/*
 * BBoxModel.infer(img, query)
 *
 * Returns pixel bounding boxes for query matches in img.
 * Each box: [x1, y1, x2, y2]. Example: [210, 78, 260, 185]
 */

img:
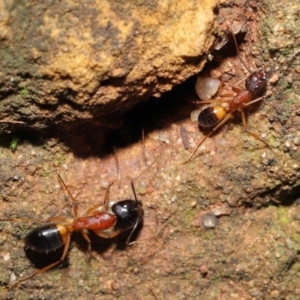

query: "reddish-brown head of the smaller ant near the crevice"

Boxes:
[245, 70, 268, 97]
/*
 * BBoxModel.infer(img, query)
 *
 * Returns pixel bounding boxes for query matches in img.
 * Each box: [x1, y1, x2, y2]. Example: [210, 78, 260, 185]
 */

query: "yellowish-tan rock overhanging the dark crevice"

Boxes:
[0, 0, 218, 128]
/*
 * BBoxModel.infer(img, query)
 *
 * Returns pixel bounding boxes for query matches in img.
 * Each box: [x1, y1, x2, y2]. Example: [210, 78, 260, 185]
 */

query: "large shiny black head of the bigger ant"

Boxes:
[111, 182, 144, 244]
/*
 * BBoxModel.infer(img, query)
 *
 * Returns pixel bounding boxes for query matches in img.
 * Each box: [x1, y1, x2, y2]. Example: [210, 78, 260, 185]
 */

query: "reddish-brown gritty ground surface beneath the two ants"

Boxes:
[0, 0, 300, 300]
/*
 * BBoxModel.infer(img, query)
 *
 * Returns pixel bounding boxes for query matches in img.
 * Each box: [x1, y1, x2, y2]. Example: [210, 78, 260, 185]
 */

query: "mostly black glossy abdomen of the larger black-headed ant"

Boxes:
[25, 224, 65, 253]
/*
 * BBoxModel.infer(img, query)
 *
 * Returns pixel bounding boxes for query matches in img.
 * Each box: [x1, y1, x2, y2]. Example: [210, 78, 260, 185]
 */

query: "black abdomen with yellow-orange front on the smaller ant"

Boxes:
[198, 105, 227, 128]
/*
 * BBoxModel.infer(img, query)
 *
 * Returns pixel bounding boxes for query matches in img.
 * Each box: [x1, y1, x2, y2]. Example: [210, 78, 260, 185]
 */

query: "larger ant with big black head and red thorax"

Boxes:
[0, 174, 144, 289]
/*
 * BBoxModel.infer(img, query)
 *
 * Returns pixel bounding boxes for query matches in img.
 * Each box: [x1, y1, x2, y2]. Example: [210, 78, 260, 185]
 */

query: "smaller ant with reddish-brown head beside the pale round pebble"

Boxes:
[185, 33, 271, 163]
